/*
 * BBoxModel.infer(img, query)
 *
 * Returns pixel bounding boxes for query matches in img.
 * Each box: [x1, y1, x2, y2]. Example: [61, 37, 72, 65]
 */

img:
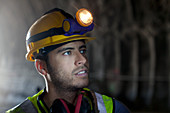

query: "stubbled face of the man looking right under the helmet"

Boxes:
[47, 41, 89, 90]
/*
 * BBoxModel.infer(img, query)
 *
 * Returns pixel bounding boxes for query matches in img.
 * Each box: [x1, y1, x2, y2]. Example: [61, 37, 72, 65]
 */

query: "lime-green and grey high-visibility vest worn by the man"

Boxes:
[6, 90, 114, 113]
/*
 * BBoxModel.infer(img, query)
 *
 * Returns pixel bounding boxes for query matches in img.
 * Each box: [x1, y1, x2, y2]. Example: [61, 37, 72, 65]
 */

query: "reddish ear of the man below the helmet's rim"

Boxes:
[35, 59, 47, 75]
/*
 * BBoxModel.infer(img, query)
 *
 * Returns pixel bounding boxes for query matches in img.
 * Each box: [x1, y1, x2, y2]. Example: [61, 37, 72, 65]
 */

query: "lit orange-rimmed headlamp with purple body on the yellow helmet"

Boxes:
[63, 8, 94, 35]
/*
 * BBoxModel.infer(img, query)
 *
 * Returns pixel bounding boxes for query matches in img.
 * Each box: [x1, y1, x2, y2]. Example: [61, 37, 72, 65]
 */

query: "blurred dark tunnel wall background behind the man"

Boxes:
[0, 0, 170, 113]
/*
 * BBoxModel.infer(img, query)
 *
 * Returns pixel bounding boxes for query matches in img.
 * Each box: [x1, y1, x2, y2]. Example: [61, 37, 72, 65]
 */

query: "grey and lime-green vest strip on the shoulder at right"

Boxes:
[95, 92, 113, 113]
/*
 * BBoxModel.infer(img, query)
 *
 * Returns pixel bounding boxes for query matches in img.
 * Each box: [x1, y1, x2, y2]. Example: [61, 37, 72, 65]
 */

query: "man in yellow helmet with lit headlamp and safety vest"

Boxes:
[7, 8, 129, 113]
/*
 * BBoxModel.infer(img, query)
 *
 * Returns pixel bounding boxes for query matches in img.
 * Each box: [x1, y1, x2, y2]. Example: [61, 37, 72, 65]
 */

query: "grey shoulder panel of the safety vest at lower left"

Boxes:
[6, 99, 37, 113]
